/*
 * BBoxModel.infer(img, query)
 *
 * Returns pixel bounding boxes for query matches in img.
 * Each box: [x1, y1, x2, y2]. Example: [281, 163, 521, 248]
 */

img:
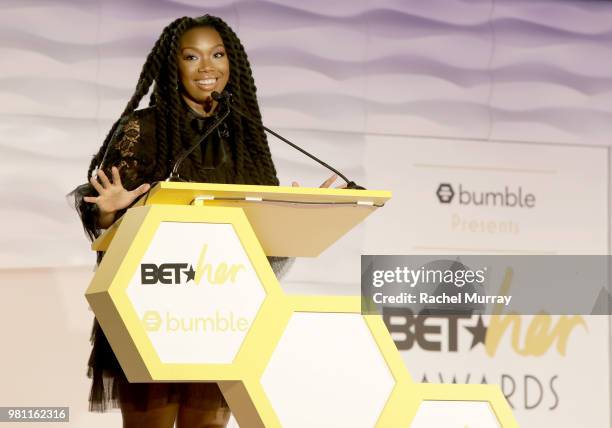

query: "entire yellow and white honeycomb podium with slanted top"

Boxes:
[86, 182, 516, 428]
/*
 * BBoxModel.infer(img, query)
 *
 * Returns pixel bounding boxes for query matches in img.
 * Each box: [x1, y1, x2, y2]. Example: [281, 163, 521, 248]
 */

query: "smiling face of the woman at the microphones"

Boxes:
[177, 27, 230, 116]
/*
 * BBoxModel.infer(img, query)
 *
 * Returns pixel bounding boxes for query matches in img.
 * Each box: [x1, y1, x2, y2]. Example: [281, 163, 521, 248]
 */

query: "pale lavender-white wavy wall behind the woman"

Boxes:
[0, 0, 612, 426]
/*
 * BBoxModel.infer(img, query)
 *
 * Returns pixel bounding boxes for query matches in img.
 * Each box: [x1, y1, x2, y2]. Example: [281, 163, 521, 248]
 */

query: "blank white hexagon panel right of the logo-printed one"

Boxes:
[261, 312, 395, 428]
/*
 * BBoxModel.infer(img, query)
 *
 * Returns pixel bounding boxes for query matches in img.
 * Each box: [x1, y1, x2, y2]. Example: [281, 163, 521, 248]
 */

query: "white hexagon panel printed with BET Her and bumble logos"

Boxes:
[126, 222, 265, 364]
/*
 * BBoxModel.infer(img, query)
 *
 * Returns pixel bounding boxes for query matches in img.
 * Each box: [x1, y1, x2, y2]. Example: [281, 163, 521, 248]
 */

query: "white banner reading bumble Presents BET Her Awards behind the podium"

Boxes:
[367, 137, 610, 427]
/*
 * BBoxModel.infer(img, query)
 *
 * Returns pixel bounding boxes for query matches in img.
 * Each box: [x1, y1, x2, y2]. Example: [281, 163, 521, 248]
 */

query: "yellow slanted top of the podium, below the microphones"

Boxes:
[92, 182, 391, 257]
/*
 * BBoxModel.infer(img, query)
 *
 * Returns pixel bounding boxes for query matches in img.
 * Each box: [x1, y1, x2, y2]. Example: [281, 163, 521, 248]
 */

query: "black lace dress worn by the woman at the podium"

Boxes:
[74, 105, 287, 411]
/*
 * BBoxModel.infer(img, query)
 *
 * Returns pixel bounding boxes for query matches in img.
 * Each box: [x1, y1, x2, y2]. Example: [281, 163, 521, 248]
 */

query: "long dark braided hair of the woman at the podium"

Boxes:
[75, 15, 279, 238]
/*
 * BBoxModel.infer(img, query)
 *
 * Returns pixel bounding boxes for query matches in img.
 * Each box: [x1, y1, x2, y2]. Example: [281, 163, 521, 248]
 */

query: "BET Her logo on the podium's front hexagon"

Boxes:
[140, 244, 246, 285]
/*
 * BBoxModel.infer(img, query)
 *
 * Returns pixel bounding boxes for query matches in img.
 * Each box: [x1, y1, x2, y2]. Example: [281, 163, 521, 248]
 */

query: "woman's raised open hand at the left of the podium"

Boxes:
[83, 167, 151, 217]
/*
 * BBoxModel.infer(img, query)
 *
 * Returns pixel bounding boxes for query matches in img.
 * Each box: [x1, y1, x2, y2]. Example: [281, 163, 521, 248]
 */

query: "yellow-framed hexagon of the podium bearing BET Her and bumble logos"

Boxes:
[86, 206, 280, 382]
